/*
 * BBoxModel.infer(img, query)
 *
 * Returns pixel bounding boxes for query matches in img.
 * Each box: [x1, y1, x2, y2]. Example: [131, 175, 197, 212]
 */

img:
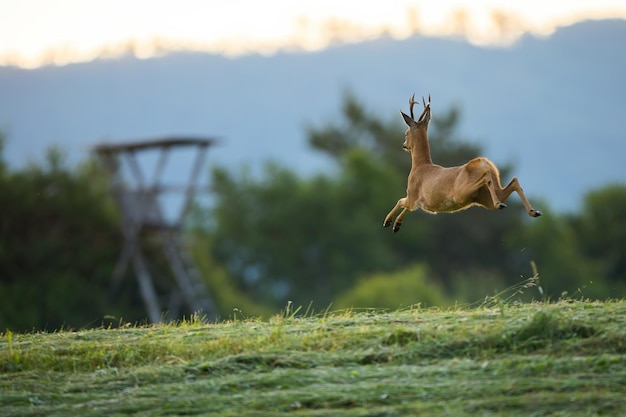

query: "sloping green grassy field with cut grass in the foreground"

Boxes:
[0, 301, 626, 417]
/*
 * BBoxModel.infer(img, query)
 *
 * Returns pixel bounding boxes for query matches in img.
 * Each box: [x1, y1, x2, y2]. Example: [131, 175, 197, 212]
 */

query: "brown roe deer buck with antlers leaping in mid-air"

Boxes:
[383, 94, 541, 233]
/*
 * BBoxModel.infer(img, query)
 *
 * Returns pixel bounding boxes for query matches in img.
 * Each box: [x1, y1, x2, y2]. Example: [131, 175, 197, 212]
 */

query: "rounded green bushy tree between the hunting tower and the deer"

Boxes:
[205, 151, 397, 305]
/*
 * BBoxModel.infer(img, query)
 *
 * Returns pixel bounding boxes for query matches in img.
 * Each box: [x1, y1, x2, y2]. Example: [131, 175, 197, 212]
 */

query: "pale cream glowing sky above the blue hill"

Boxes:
[0, 0, 626, 68]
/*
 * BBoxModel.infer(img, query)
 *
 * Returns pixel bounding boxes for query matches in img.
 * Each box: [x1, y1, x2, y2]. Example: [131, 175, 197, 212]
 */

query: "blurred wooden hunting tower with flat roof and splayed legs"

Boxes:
[94, 138, 217, 323]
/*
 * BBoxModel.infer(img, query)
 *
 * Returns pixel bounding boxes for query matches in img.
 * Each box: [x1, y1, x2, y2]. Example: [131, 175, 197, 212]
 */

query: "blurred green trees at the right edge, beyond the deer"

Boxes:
[512, 184, 626, 299]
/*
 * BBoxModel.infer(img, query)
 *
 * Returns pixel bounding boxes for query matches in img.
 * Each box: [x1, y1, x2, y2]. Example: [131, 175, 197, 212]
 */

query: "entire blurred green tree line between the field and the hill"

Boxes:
[0, 94, 626, 330]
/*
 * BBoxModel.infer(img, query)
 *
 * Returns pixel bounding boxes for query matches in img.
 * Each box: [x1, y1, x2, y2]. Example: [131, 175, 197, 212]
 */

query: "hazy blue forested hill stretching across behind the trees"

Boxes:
[0, 20, 626, 210]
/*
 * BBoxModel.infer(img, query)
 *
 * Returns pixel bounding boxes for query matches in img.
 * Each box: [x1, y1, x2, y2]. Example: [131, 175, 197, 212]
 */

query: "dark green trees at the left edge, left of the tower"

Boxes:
[0, 141, 143, 331]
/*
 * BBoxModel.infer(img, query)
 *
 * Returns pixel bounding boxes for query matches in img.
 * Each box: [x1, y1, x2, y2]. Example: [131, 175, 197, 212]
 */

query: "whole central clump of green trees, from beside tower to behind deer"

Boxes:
[210, 91, 526, 308]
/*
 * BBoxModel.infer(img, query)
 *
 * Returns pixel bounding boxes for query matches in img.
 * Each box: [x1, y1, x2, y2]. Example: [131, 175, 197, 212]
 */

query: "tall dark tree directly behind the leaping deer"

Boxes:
[307, 93, 525, 289]
